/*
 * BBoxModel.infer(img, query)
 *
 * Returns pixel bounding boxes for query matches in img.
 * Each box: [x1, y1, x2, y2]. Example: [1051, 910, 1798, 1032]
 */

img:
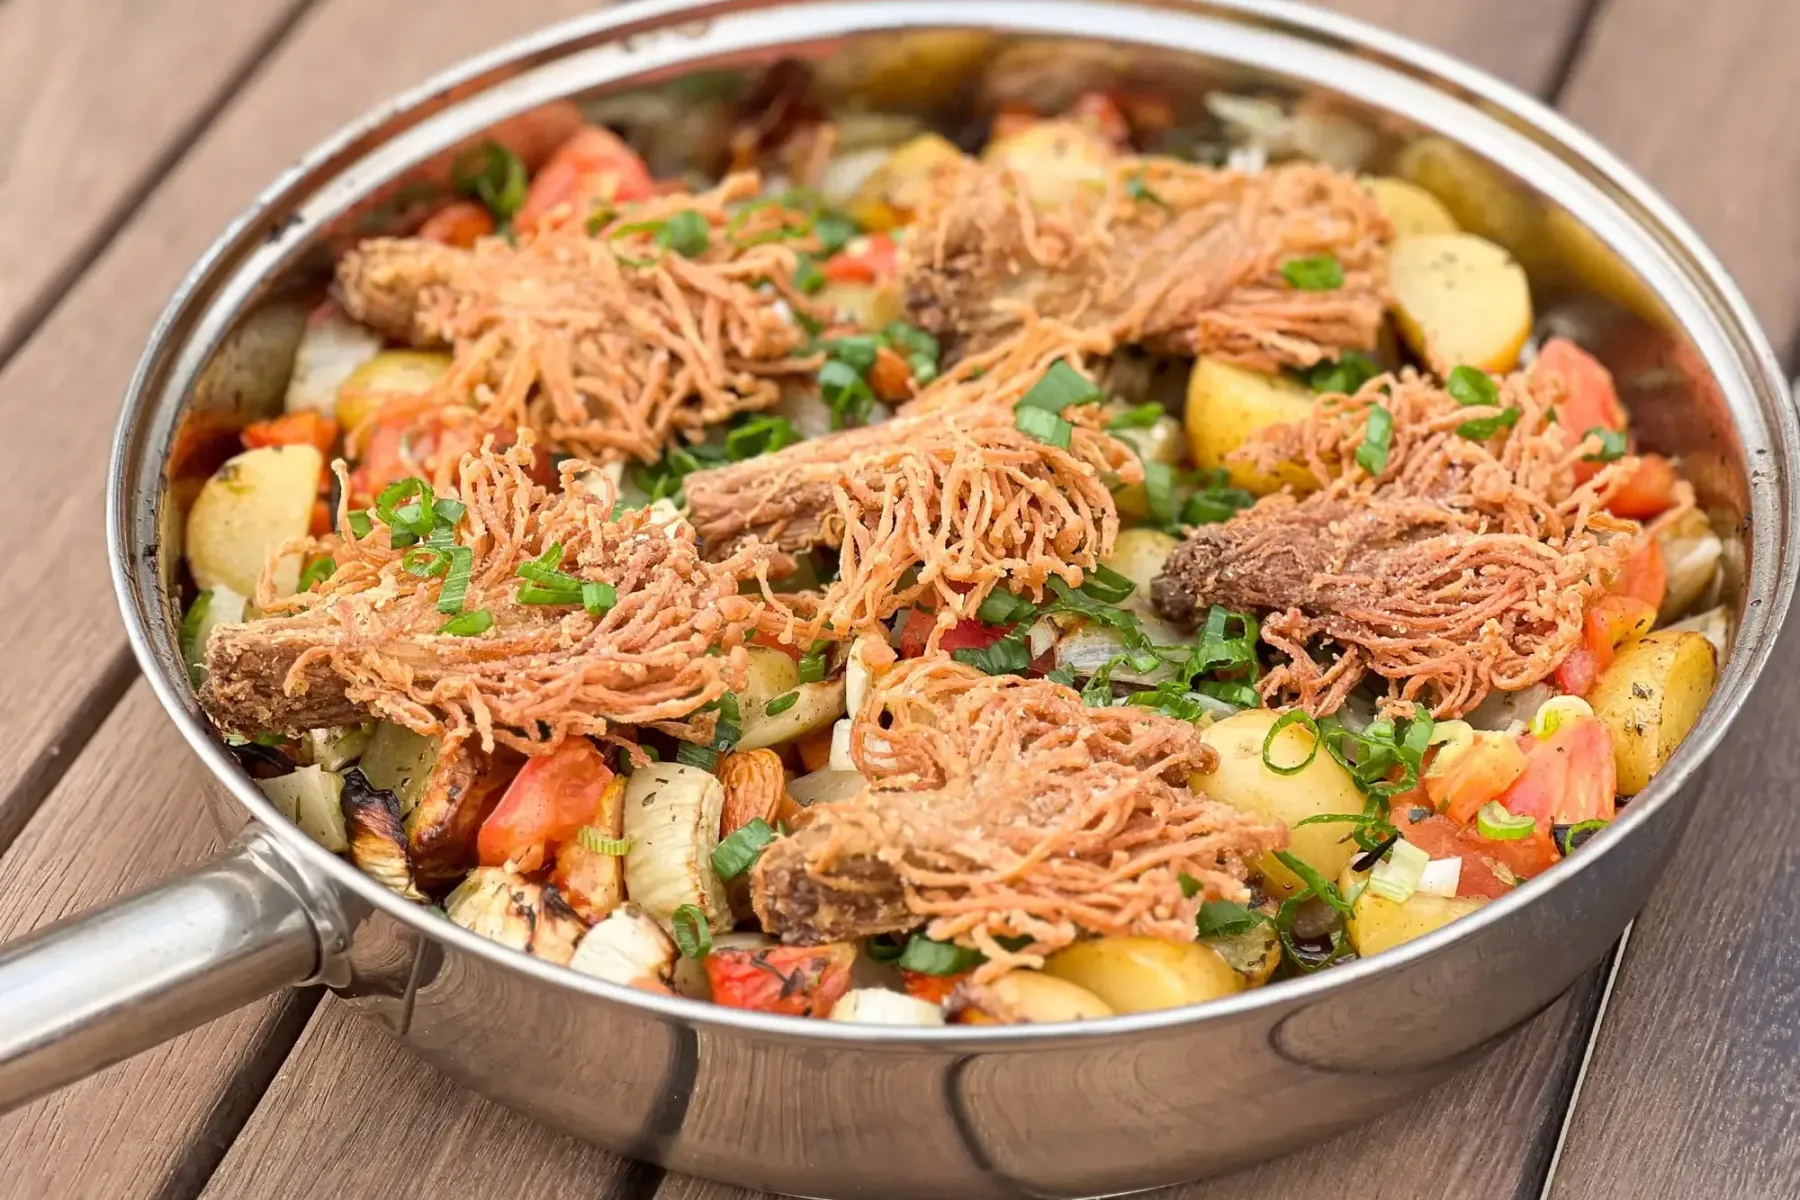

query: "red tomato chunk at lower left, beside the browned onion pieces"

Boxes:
[475, 738, 612, 871]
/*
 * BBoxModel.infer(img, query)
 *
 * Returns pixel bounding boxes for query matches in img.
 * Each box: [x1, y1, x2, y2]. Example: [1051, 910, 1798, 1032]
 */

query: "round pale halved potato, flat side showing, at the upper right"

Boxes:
[1388, 234, 1532, 374]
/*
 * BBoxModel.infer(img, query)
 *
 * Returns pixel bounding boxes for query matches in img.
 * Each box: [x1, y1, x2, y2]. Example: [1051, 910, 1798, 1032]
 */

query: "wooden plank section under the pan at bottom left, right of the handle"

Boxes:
[202, 999, 646, 1200]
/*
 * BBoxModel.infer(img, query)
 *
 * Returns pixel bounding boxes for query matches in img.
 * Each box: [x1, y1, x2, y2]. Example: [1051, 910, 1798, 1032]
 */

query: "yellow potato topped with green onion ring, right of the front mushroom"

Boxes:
[1193, 709, 1363, 900]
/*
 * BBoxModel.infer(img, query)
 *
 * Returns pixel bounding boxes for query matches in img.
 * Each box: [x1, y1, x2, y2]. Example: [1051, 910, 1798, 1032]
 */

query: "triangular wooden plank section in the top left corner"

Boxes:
[0, 0, 306, 360]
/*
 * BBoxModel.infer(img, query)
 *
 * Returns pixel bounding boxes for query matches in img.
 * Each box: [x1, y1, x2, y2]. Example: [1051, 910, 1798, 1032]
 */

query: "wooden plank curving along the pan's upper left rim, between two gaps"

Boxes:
[0, 0, 592, 846]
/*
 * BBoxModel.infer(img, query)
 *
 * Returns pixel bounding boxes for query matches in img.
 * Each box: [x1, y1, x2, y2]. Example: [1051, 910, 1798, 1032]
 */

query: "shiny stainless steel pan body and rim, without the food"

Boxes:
[0, 0, 1800, 1198]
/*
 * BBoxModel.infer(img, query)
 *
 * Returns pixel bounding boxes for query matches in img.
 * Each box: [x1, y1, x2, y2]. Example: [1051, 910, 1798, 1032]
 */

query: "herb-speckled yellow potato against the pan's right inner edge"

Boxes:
[1588, 630, 1719, 795]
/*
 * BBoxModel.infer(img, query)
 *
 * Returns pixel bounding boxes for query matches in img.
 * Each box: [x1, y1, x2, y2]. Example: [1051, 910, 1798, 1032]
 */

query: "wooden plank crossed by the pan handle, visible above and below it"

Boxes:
[0, 684, 317, 1200]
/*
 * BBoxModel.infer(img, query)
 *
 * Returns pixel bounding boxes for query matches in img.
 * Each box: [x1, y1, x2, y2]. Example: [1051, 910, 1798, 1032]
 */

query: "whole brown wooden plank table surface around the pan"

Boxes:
[0, 0, 1800, 1200]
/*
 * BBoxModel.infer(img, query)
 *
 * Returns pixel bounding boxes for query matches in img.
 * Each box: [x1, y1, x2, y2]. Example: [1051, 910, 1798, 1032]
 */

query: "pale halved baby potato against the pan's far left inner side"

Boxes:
[187, 446, 326, 597]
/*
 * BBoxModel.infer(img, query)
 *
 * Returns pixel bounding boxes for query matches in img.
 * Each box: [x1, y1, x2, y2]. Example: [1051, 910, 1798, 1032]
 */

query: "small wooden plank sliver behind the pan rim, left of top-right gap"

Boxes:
[1321, 0, 1591, 95]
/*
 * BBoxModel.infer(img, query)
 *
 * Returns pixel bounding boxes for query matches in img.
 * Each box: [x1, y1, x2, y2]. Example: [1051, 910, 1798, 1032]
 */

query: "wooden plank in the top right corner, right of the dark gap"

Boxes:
[1562, 0, 1800, 347]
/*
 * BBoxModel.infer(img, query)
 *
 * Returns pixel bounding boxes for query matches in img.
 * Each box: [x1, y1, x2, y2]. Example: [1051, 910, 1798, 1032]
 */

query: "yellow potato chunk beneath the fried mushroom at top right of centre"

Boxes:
[1184, 358, 1318, 497]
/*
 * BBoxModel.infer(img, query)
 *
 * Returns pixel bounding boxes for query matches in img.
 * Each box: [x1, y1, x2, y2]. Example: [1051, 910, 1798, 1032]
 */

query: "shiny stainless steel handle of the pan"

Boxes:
[0, 826, 338, 1112]
